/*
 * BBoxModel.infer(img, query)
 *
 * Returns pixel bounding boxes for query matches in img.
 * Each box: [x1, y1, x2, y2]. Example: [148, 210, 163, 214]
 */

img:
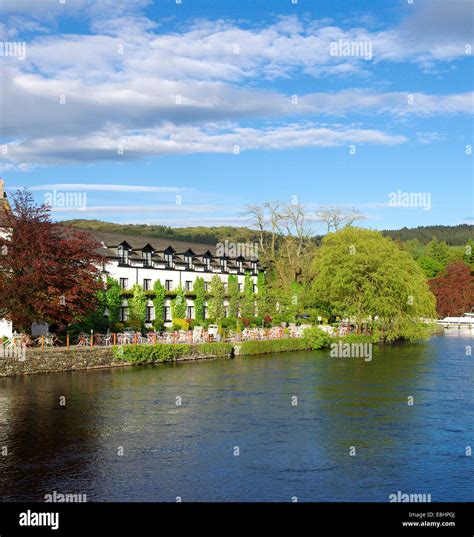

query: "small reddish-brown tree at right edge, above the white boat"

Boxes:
[428, 261, 474, 317]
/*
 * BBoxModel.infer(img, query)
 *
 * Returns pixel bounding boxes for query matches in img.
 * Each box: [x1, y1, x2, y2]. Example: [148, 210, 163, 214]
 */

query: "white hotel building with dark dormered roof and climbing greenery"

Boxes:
[92, 232, 264, 325]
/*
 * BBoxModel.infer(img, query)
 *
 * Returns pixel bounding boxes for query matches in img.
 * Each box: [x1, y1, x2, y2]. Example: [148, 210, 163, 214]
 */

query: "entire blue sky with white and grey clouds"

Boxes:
[0, 0, 474, 231]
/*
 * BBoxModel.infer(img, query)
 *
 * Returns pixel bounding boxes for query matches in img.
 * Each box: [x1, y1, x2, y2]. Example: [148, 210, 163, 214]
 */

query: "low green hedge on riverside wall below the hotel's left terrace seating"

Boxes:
[114, 343, 233, 364]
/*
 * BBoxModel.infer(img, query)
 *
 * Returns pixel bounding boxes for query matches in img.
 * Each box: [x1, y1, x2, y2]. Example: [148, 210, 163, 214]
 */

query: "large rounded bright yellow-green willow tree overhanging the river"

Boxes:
[313, 227, 436, 340]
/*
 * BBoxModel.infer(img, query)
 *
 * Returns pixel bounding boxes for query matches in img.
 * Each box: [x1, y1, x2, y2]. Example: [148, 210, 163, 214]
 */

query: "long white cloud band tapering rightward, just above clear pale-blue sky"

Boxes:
[0, 122, 406, 165]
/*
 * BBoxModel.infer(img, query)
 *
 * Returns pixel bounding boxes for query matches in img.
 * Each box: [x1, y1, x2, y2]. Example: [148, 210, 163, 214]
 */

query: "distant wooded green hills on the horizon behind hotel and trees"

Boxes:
[63, 220, 474, 246]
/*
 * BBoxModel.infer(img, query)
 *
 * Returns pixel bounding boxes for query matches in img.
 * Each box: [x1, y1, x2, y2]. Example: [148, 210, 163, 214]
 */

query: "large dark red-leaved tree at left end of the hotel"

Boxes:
[0, 190, 103, 331]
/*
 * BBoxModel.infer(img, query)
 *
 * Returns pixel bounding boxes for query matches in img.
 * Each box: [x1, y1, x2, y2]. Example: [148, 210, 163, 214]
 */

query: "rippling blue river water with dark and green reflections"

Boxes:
[0, 333, 474, 501]
